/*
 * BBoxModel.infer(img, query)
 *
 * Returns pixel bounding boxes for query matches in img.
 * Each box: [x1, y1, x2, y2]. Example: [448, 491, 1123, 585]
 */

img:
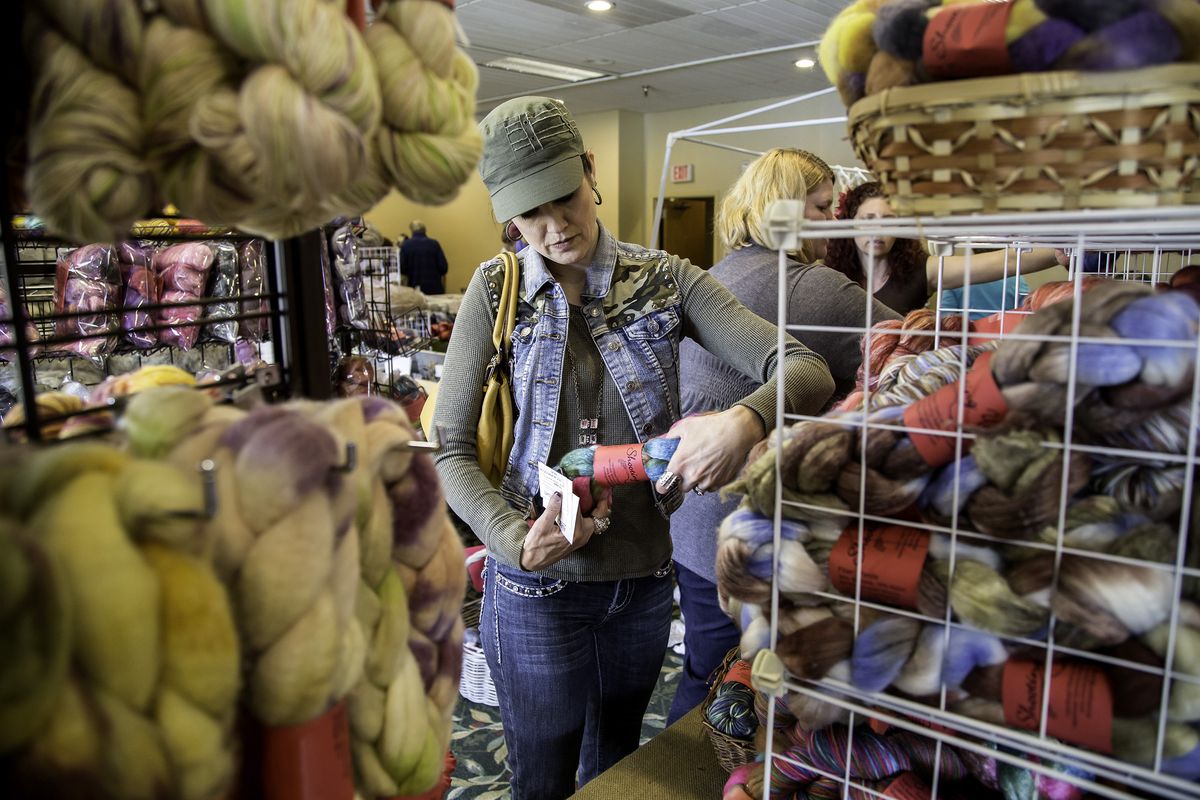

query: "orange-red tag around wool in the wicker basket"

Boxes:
[920, 2, 1013, 78]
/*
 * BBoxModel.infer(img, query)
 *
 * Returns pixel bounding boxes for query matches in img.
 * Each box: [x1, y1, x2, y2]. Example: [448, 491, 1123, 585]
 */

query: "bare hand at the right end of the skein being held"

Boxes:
[654, 405, 767, 494]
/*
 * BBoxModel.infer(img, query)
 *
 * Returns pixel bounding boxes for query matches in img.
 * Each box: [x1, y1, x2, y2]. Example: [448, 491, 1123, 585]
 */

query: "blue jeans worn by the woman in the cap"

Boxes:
[480, 558, 673, 800]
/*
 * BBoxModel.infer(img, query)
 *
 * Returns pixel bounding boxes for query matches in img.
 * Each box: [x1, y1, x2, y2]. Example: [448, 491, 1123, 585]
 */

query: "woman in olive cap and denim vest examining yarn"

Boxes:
[434, 97, 833, 800]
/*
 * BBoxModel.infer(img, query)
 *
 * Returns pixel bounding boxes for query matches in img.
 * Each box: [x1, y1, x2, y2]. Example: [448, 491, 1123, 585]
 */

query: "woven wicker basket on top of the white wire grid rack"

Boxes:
[850, 64, 1200, 216]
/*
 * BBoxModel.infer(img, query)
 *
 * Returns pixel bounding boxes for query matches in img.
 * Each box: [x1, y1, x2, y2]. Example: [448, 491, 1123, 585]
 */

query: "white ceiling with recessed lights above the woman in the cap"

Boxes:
[456, 0, 846, 115]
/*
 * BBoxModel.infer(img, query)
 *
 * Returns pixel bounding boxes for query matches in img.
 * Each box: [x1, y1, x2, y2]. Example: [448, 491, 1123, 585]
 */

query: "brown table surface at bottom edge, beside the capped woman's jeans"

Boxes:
[571, 706, 728, 800]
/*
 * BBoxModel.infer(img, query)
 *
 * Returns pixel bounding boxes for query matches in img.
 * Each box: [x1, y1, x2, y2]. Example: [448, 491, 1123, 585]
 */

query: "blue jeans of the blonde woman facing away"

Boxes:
[667, 561, 742, 724]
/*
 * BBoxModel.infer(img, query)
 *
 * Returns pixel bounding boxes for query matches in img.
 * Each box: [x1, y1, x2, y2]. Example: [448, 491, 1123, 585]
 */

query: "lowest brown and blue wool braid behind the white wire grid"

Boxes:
[852, 616, 1200, 775]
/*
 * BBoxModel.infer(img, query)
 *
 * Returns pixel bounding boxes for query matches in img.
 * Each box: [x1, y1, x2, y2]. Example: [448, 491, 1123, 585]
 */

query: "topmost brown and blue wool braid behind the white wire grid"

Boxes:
[731, 283, 1200, 525]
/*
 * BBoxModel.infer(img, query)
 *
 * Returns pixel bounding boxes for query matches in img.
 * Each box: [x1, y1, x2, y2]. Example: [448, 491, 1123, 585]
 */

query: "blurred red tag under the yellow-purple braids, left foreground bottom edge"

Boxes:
[263, 700, 354, 800]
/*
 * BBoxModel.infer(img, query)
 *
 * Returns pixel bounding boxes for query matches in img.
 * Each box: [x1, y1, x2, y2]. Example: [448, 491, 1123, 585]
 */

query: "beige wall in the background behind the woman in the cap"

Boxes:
[366, 95, 858, 291]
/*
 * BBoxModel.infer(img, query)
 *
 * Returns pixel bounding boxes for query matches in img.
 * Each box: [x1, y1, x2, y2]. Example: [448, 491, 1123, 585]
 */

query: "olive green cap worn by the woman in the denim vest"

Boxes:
[479, 97, 586, 222]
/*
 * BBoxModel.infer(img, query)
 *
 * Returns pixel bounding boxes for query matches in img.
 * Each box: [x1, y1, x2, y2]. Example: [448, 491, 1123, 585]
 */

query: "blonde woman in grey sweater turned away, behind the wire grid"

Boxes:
[667, 148, 899, 724]
